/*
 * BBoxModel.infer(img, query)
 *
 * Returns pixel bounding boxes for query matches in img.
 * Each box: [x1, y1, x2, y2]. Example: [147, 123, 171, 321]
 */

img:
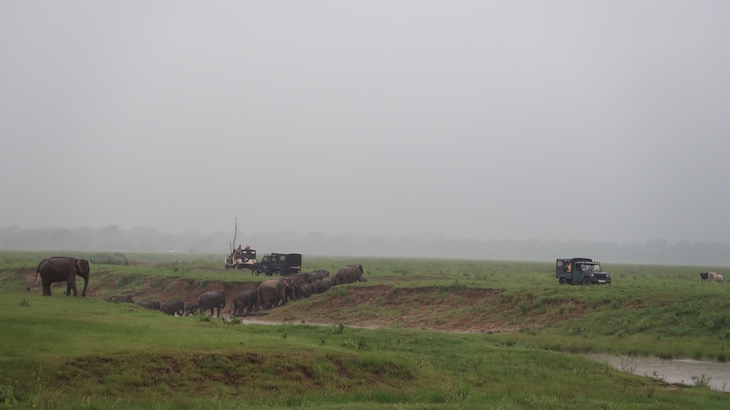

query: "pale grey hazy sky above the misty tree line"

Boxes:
[0, 0, 730, 242]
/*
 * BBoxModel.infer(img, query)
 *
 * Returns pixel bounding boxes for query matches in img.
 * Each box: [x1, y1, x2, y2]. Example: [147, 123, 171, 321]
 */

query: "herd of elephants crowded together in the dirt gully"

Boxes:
[107, 265, 367, 318]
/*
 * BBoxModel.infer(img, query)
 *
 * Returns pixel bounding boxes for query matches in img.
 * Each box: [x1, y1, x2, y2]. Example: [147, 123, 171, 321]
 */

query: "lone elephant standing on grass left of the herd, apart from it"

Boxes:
[27, 256, 90, 297]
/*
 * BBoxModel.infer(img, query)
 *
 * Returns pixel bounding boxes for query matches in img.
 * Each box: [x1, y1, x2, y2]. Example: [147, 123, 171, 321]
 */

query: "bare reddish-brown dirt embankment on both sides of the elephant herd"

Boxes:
[21, 274, 545, 333]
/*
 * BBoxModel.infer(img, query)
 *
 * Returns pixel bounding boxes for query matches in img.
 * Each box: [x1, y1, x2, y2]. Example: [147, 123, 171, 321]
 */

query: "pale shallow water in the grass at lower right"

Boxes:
[585, 354, 730, 392]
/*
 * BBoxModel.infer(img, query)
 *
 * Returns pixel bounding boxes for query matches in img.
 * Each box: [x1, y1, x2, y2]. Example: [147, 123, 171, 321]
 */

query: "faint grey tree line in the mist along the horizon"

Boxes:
[0, 226, 730, 266]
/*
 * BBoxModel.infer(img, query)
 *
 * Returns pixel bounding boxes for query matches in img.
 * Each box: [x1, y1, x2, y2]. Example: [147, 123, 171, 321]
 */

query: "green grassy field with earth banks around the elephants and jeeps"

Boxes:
[0, 252, 730, 409]
